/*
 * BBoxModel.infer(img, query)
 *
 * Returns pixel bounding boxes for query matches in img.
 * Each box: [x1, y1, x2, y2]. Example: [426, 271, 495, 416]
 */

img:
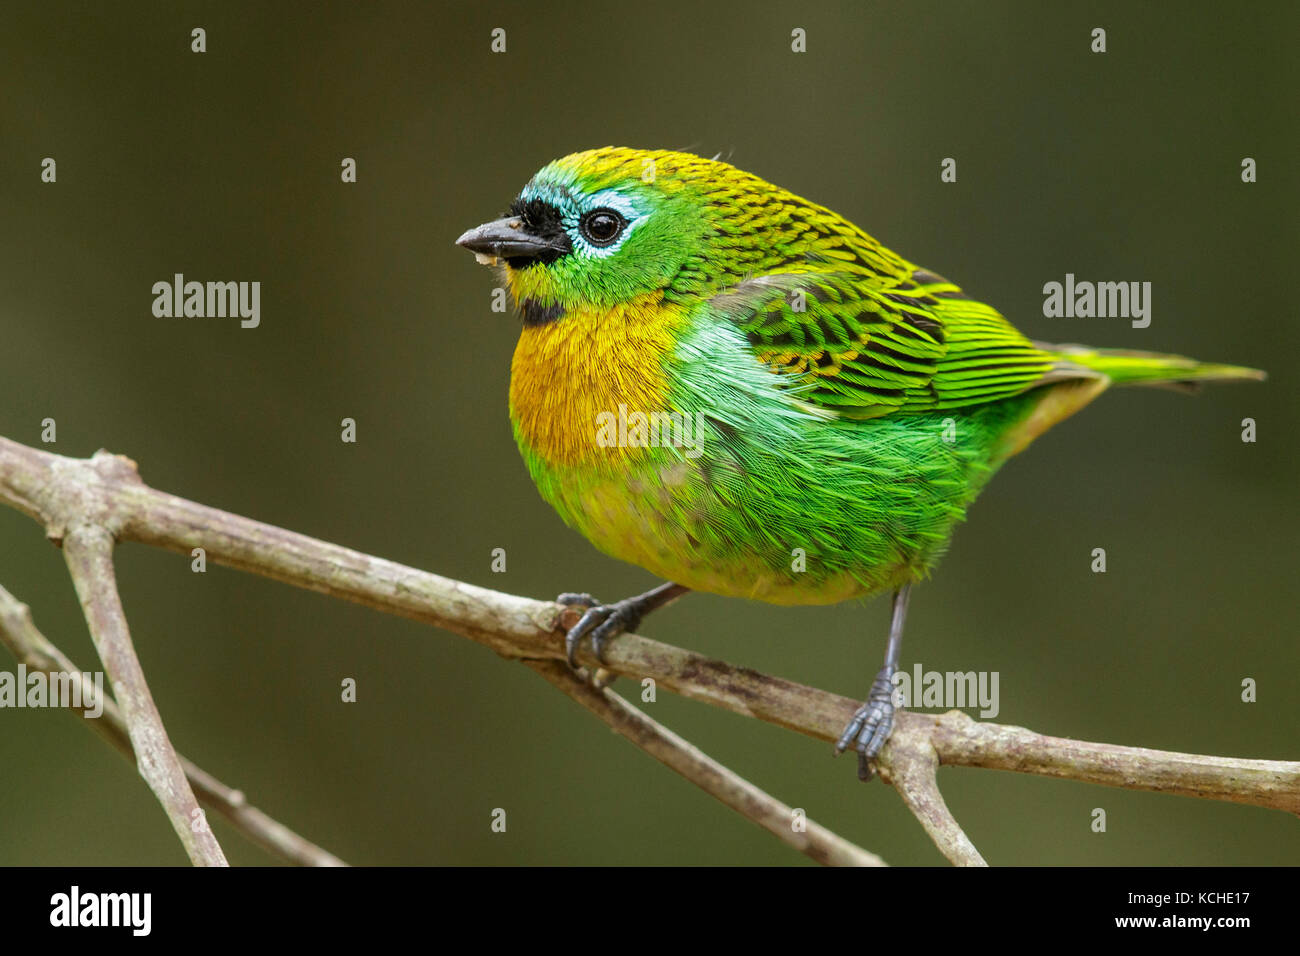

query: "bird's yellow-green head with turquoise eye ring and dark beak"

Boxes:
[456, 147, 826, 323]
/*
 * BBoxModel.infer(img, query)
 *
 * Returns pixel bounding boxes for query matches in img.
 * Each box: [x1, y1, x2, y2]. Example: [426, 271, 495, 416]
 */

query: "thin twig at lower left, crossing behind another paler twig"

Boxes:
[0, 587, 347, 866]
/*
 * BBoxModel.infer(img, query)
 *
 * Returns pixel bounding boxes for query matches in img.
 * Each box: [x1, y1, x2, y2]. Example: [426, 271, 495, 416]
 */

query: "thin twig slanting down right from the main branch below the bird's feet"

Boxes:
[524, 661, 887, 866]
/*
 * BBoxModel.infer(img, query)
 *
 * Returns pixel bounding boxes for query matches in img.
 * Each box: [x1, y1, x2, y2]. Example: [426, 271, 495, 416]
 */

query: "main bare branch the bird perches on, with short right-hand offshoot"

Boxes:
[0, 438, 1300, 862]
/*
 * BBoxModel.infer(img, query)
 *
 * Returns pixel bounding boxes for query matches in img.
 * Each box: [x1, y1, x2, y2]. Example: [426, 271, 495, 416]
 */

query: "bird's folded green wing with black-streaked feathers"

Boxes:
[710, 269, 1093, 419]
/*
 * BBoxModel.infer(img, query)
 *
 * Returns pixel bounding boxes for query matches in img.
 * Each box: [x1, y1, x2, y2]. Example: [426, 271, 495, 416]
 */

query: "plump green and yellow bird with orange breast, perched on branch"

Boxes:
[456, 147, 1265, 780]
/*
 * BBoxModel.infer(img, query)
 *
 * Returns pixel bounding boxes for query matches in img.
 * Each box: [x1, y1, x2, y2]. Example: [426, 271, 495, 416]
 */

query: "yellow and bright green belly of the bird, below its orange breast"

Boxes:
[514, 413, 974, 605]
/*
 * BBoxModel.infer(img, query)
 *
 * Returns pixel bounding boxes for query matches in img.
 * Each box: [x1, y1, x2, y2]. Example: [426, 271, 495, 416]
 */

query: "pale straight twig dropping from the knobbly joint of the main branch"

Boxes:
[64, 524, 229, 866]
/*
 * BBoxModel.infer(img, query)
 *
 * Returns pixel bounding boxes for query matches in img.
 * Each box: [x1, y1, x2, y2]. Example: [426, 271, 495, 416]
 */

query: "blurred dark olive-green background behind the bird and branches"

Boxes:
[0, 3, 1300, 865]
